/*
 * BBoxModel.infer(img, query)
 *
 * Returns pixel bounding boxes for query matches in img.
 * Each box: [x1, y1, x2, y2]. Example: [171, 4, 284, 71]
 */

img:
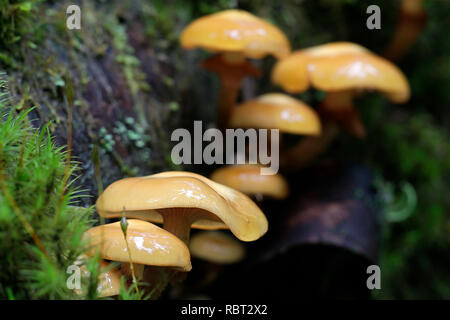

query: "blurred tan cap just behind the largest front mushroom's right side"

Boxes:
[211, 164, 289, 199]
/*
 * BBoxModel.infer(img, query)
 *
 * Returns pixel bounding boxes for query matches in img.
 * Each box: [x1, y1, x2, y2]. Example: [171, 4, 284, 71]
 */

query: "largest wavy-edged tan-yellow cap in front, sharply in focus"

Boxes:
[96, 171, 268, 241]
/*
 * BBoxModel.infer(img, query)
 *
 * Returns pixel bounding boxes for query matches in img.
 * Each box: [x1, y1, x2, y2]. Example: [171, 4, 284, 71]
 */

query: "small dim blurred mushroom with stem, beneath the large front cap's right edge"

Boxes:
[189, 231, 246, 287]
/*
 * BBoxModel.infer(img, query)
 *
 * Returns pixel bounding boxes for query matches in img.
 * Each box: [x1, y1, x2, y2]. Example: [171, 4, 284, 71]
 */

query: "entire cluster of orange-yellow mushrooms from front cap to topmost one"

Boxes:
[81, 10, 410, 296]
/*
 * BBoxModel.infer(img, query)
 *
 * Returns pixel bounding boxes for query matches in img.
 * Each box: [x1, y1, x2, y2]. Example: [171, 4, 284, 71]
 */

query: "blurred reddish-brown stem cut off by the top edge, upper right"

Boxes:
[383, 0, 427, 61]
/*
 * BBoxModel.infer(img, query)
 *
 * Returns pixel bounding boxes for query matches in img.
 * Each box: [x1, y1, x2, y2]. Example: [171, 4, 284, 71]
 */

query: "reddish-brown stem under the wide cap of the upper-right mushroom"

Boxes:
[319, 90, 366, 139]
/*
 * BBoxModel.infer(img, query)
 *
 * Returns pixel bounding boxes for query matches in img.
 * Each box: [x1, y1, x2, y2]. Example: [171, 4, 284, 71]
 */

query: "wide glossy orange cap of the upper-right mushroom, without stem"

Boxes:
[272, 42, 410, 103]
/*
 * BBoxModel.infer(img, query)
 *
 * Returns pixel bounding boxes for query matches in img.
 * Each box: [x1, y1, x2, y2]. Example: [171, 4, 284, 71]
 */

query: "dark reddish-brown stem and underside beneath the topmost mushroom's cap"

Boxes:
[203, 53, 261, 131]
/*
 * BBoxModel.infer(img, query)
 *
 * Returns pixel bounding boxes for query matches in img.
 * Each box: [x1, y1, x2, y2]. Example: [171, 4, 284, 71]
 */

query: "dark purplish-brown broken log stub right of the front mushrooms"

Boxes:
[263, 163, 380, 262]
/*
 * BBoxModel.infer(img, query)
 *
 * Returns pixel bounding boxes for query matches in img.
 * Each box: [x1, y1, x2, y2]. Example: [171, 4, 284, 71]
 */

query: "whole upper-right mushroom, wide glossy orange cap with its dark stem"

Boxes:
[272, 42, 410, 170]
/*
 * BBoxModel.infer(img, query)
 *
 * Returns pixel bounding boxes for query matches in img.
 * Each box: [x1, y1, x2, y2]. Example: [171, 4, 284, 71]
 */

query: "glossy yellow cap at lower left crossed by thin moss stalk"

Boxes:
[85, 219, 192, 271]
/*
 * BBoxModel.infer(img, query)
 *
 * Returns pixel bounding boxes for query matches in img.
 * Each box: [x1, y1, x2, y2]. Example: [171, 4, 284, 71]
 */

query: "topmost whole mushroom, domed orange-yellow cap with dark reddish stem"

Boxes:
[180, 10, 290, 129]
